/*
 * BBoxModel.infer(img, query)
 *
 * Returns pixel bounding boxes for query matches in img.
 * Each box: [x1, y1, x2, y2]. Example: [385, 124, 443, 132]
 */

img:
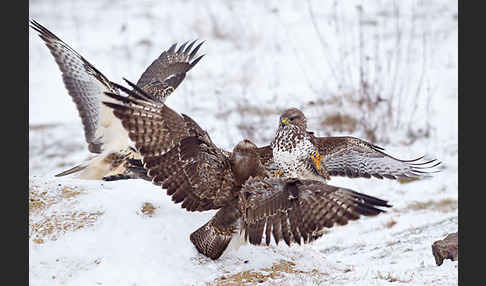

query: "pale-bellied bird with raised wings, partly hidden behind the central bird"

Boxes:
[30, 20, 204, 180]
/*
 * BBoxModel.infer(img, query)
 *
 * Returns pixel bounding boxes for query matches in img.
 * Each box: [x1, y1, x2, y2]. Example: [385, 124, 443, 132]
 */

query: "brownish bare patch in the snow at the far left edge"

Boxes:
[29, 182, 103, 244]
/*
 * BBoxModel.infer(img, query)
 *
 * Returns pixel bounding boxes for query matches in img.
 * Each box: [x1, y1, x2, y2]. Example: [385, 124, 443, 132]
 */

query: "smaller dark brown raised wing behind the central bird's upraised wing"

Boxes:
[137, 41, 204, 102]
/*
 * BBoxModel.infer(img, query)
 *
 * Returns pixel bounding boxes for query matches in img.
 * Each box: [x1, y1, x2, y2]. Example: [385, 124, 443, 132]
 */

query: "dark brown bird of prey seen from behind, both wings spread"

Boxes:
[103, 81, 390, 259]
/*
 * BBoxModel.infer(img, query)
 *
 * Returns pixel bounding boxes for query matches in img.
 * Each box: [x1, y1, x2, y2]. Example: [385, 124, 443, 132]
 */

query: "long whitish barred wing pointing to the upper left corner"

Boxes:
[30, 20, 123, 153]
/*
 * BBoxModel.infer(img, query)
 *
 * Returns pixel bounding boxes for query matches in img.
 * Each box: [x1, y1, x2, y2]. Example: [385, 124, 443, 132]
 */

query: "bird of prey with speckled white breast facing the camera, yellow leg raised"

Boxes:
[268, 108, 440, 181]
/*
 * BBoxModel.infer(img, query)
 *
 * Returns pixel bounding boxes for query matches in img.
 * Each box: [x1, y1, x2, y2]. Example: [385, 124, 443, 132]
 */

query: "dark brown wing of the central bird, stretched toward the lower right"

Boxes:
[239, 178, 390, 245]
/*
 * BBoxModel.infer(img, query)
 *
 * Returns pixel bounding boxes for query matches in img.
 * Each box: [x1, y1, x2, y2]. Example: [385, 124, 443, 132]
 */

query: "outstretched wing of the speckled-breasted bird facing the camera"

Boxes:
[311, 134, 440, 179]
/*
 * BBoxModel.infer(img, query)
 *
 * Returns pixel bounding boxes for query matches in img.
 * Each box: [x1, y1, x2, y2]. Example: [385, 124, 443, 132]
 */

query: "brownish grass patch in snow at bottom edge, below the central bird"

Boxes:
[212, 259, 328, 286]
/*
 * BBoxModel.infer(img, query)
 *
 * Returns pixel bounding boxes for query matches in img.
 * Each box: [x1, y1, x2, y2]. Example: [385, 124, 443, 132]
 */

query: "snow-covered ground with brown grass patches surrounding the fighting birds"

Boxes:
[29, 0, 458, 286]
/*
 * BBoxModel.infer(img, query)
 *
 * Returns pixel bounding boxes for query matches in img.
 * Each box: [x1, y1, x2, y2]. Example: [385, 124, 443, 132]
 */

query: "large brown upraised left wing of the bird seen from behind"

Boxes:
[104, 81, 235, 211]
